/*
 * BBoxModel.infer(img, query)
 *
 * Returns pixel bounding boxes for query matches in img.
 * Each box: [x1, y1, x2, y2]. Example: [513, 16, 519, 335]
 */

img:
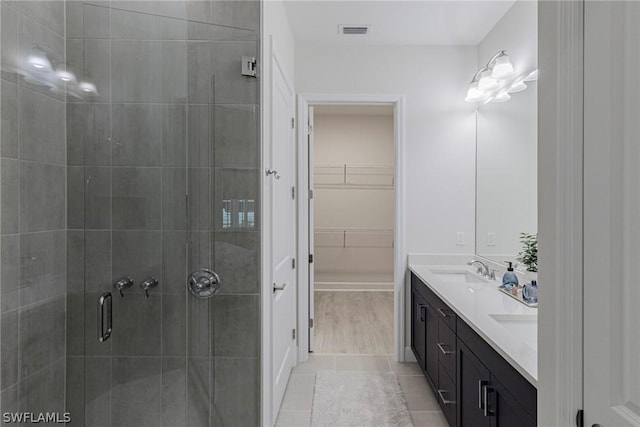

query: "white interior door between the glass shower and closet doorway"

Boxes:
[268, 54, 297, 422]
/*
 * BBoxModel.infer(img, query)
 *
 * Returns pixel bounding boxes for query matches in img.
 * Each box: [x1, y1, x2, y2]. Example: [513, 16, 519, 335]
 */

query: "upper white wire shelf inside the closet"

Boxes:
[313, 164, 394, 189]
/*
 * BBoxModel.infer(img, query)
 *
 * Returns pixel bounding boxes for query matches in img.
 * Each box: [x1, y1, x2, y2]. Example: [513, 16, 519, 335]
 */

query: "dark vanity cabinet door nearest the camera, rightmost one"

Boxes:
[487, 376, 536, 427]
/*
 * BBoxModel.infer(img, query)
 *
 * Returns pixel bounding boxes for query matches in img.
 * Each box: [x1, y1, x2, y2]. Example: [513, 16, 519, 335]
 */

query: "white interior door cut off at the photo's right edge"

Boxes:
[584, 1, 640, 427]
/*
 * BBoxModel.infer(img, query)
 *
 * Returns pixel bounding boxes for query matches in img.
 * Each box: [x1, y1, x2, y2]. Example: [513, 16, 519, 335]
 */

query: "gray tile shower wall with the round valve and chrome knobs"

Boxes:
[60, 0, 260, 427]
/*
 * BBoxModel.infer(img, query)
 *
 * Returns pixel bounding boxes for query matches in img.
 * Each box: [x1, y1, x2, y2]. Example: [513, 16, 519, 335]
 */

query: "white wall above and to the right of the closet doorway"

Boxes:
[296, 45, 477, 254]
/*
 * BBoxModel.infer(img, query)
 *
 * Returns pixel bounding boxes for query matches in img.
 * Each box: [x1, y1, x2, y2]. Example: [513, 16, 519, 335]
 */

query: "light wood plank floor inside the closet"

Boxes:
[314, 291, 393, 354]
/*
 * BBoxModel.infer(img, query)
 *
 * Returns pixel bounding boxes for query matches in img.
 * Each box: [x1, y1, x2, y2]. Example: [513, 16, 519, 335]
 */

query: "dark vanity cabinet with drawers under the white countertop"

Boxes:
[411, 273, 537, 427]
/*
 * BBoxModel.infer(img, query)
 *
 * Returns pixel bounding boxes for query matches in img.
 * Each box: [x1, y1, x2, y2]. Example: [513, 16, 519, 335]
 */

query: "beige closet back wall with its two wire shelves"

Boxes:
[313, 106, 394, 290]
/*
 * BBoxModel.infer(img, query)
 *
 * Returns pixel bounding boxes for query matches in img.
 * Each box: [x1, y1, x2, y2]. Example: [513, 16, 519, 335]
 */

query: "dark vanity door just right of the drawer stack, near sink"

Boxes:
[457, 339, 490, 427]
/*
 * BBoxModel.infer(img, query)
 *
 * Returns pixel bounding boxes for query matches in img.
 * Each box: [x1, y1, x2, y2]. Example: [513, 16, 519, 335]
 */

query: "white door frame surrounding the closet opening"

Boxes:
[297, 93, 407, 362]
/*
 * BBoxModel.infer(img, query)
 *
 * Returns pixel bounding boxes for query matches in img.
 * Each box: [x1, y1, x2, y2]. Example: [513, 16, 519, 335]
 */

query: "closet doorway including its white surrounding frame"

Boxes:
[298, 95, 404, 361]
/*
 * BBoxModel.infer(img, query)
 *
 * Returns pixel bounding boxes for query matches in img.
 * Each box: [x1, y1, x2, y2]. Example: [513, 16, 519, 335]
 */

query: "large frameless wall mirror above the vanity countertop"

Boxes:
[476, 81, 538, 271]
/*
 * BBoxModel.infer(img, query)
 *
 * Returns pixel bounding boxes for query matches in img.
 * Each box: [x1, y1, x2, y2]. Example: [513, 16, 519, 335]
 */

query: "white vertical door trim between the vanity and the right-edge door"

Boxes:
[538, 1, 584, 426]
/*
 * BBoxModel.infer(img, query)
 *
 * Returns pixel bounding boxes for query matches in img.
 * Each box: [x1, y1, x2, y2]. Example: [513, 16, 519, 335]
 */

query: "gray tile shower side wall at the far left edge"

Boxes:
[0, 1, 67, 422]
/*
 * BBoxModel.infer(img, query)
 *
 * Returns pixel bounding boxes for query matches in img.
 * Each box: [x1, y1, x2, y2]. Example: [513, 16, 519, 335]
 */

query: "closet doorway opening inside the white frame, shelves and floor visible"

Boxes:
[308, 104, 394, 354]
